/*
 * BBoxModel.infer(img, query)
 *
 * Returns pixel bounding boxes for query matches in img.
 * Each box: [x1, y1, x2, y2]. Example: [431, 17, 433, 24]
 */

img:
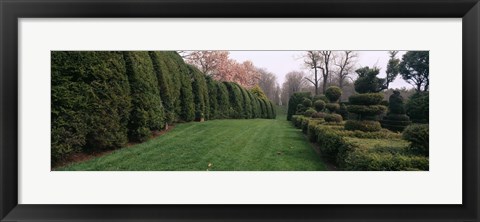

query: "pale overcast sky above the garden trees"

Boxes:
[230, 51, 412, 88]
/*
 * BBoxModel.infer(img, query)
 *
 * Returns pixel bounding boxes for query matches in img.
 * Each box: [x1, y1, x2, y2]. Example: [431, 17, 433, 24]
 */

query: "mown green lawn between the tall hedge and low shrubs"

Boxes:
[55, 109, 326, 171]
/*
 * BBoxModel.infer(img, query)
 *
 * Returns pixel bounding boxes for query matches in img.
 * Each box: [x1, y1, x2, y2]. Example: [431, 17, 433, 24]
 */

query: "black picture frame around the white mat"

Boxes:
[0, 0, 480, 221]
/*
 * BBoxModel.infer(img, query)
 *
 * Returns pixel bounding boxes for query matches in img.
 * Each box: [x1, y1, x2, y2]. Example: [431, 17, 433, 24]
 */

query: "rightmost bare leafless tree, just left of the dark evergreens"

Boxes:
[334, 51, 358, 89]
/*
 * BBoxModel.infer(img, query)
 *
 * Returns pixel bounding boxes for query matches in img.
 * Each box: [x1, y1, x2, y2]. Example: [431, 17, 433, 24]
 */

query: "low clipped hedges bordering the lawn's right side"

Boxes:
[291, 115, 429, 171]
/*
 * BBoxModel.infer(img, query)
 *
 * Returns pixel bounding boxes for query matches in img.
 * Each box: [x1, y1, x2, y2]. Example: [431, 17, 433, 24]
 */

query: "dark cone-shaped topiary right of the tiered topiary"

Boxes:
[380, 90, 411, 132]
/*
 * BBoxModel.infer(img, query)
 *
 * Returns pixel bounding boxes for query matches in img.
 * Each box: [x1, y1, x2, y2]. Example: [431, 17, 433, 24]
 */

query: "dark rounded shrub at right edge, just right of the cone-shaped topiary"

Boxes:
[405, 92, 429, 123]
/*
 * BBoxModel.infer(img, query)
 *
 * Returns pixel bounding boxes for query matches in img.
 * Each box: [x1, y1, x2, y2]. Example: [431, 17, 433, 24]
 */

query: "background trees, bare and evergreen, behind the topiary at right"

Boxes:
[280, 51, 429, 104]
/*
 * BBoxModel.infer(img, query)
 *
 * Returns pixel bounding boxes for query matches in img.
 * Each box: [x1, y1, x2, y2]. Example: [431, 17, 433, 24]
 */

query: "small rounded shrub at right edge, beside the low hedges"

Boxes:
[402, 124, 429, 156]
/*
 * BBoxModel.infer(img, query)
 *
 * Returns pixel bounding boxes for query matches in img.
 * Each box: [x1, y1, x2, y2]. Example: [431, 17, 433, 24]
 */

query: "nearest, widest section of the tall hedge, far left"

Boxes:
[52, 52, 131, 161]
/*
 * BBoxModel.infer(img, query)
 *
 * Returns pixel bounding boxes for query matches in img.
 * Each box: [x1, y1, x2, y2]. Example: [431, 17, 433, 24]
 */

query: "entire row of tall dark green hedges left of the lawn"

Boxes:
[51, 51, 276, 163]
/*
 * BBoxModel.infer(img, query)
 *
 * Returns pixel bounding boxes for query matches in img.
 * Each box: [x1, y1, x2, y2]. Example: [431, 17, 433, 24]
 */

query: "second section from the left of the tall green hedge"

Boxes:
[123, 52, 165, 141]
